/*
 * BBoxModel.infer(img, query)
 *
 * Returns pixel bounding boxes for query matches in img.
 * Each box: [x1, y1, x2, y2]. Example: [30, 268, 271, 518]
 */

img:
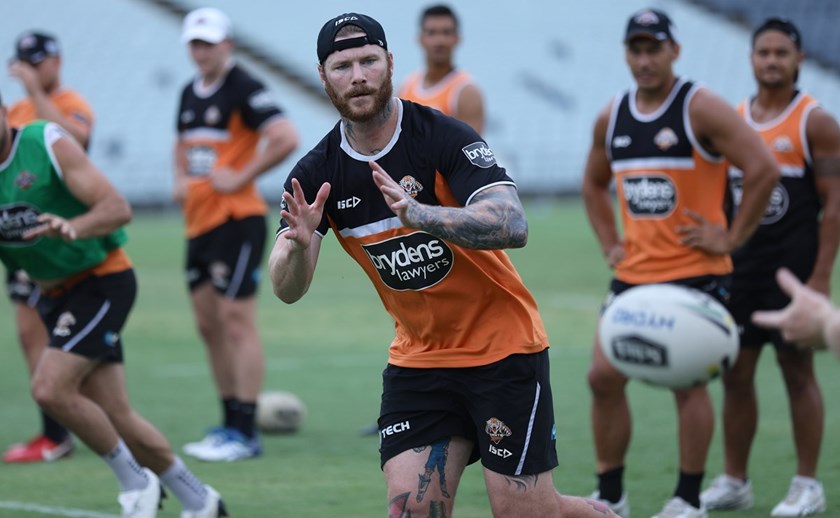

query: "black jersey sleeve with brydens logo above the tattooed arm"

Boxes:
[432, 117, 516, 205]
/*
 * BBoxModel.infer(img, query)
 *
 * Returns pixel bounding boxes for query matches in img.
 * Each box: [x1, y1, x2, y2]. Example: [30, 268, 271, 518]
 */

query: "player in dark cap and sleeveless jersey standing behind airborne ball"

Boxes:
[583, 9, 779, 518]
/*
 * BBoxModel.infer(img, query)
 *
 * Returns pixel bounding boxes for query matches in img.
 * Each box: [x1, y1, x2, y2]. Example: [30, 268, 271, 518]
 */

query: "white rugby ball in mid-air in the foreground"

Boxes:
[598, 284, 738, 389]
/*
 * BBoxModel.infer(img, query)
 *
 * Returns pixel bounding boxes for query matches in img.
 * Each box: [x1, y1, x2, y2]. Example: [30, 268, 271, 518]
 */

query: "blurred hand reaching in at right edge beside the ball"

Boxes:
[752, 268, 834, 348]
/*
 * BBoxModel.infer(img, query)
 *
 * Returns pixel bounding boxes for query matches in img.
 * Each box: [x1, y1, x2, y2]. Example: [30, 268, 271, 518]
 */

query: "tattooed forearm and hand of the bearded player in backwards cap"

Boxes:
[370, 161, 528, 250]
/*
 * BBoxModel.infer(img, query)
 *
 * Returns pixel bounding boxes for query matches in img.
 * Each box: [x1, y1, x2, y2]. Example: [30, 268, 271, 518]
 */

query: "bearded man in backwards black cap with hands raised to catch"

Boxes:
[269, 13, 613, 517]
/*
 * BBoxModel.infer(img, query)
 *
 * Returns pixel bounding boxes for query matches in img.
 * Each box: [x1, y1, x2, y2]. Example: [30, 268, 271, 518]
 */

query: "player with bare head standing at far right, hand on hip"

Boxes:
[702, 18, 840, 516]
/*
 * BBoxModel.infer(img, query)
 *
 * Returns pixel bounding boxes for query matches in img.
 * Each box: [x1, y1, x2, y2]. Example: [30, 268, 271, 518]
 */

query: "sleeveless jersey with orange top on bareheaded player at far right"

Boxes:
[729, 92, 822, 287]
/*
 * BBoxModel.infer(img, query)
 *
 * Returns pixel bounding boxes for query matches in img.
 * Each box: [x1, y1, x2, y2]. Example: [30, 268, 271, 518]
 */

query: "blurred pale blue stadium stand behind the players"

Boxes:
[0, 0, 840, 205]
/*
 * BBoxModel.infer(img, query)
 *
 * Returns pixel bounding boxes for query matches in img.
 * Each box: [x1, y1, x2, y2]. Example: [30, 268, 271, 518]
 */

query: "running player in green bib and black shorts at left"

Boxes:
[0, 91, 226, 518]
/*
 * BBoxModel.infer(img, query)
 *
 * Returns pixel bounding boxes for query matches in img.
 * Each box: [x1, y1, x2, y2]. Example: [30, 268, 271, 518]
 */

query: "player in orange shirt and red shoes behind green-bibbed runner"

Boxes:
[3, 31, 93, 462]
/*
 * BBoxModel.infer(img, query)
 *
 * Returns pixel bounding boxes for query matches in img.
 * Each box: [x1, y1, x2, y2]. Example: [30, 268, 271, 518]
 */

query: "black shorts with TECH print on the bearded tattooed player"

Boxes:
[379, 349, 557, 476]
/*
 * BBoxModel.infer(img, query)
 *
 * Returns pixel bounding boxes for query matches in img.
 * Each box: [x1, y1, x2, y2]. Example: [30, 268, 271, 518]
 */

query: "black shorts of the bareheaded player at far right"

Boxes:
[729, 284, 796, 349]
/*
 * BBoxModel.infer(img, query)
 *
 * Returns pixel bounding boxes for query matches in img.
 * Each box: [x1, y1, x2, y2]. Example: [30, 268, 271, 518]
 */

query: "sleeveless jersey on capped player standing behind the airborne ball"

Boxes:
[605, 79, 732, 284]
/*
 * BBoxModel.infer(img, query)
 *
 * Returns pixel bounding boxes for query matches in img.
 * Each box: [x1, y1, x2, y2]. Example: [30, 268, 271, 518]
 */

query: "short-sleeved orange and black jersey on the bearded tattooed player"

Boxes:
[278, 101, 548, 368]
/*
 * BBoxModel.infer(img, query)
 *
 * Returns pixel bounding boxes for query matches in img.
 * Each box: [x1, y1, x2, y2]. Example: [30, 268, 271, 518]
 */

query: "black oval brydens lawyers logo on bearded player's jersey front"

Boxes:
[362, 232, 455, 291]
